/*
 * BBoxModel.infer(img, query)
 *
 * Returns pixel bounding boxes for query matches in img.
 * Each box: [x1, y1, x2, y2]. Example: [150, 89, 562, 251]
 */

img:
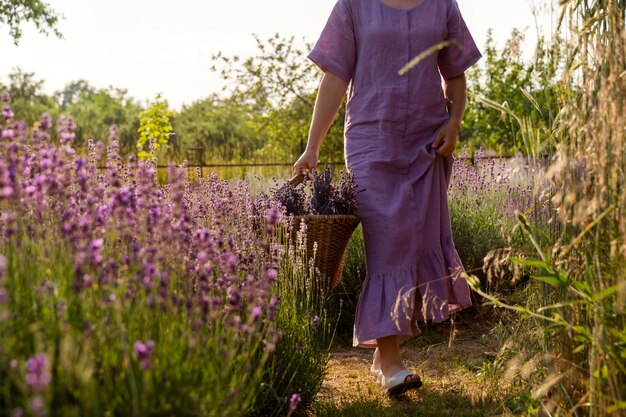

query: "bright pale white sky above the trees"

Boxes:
[0, 0, 550, 110]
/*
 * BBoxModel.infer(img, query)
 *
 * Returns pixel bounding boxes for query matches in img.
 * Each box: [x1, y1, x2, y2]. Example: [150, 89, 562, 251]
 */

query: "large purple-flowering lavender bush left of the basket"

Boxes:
[0, 96, 327, 416]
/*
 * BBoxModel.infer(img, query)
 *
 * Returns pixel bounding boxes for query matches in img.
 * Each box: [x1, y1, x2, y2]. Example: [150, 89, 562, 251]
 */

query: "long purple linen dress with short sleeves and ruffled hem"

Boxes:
[309, 0, 481, 346]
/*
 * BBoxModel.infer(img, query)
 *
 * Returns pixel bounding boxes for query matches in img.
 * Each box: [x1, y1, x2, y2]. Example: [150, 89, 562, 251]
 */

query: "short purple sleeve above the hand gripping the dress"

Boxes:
[437, 0, 482, 80]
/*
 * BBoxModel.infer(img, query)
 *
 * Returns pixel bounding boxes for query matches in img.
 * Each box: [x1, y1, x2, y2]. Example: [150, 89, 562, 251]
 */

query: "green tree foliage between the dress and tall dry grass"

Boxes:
[460, 29, 560, 154]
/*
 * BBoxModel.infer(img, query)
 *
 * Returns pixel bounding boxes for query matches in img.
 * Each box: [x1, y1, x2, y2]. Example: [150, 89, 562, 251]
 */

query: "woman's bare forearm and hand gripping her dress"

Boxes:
[431, 73, 467, 156]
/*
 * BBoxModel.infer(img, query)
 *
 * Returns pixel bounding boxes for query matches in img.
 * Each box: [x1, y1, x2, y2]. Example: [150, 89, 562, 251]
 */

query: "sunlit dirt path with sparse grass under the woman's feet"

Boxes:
[312, 312, 510, 417]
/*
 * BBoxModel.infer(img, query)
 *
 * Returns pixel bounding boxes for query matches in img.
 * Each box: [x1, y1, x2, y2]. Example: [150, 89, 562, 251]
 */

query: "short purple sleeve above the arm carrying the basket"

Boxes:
[308, 0, 356, 84]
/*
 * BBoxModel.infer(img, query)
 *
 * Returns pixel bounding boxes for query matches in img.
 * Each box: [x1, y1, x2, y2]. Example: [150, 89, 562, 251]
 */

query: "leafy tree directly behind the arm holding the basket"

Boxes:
[214, 34, 343, 161]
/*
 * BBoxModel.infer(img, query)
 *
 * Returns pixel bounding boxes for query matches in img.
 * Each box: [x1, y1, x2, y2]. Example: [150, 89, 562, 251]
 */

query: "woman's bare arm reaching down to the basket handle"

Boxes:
[293, 71, 348, 172]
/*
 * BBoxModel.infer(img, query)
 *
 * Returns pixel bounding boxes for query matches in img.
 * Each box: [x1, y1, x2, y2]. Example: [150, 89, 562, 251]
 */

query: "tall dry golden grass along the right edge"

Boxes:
[473, 0, 626, 416]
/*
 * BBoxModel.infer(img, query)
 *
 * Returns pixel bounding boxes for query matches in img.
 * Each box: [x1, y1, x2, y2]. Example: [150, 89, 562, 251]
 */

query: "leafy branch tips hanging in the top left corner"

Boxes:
[0, 0, 63, 45]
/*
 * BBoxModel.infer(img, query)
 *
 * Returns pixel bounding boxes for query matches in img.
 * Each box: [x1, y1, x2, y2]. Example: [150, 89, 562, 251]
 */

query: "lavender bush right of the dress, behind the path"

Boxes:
[448, 149, 548, 290]
